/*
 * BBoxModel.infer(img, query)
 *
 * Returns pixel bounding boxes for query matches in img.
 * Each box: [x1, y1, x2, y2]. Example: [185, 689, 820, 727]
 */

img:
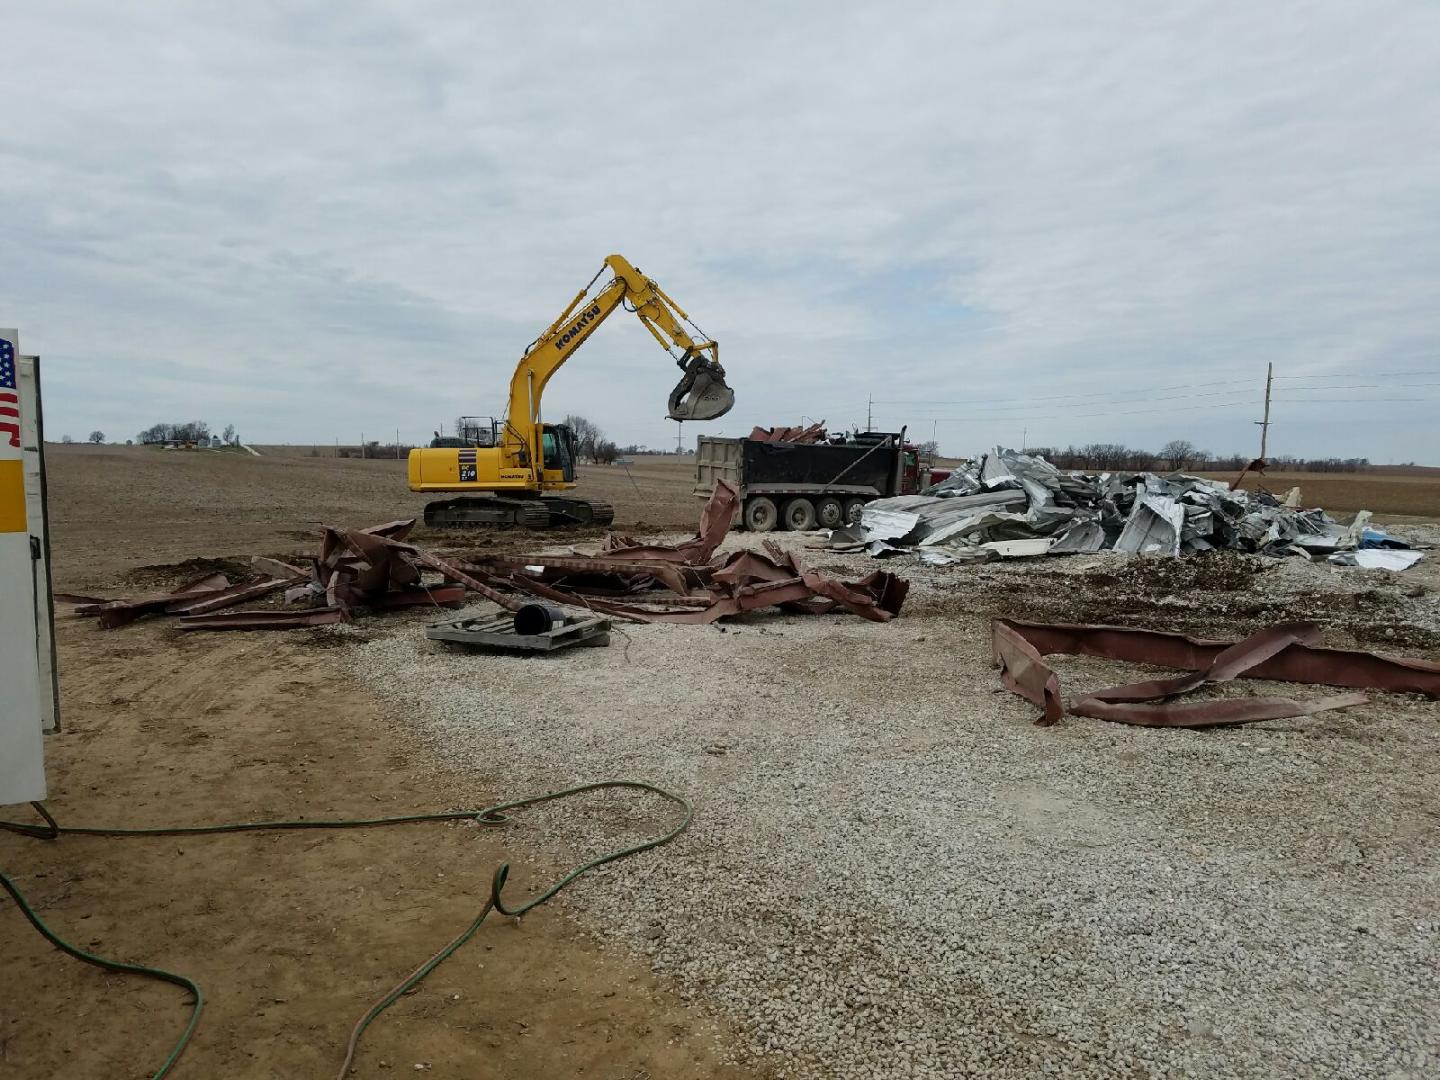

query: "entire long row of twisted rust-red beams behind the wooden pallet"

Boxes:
[59, 480, 909, 631]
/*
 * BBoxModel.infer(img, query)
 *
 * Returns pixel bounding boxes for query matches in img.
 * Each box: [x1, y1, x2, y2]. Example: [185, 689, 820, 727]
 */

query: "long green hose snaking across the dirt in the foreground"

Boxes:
[0, 780, 694, 1080]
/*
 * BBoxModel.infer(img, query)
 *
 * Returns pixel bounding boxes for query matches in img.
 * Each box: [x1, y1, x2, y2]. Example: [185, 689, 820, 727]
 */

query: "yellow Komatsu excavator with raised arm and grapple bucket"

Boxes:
[409, 255, 734, 528]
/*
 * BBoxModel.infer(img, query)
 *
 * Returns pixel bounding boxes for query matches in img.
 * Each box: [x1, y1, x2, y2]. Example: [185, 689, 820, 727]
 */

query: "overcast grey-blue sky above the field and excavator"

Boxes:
[0, 0, 1440, 464]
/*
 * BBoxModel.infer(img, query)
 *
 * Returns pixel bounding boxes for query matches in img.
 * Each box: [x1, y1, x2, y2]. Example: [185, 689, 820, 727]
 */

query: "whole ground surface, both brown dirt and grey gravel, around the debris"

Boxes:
[0, 446, 1440, 1080]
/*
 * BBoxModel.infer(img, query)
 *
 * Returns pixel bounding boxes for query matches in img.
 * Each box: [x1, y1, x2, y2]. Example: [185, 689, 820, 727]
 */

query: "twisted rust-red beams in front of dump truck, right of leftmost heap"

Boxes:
[449, 480, 910, 624]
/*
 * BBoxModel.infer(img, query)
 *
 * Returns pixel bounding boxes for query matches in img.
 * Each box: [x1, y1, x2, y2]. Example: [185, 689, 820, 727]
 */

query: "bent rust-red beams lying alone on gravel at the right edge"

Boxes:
[991, 619, 1440, 727]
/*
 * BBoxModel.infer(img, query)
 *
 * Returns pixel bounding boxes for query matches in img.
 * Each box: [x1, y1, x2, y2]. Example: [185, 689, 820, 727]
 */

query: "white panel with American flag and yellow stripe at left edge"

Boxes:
[0, 330, 45, 804]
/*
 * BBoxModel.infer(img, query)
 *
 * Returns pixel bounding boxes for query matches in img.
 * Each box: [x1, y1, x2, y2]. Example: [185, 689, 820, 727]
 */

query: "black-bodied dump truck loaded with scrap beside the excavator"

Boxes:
[694, 431, 933, 533]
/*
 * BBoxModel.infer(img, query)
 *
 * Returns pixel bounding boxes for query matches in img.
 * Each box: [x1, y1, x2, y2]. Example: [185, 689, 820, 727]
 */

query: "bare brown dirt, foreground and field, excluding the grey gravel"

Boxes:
[8, 446, 1440, 1080]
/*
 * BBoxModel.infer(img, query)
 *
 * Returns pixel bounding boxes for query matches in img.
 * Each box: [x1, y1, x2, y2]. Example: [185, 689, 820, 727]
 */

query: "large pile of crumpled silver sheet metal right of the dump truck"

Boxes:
[829, 448, 1418, 569]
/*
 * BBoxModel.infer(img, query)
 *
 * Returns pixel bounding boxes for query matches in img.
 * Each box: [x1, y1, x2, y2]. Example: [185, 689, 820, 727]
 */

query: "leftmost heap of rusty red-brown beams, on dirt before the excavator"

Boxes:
[56, 518, 465, 629]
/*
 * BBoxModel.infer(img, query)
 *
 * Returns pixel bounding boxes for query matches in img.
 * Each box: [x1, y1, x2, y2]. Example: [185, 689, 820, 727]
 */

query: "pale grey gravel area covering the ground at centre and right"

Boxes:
[346, 534, 1440, 1080]
